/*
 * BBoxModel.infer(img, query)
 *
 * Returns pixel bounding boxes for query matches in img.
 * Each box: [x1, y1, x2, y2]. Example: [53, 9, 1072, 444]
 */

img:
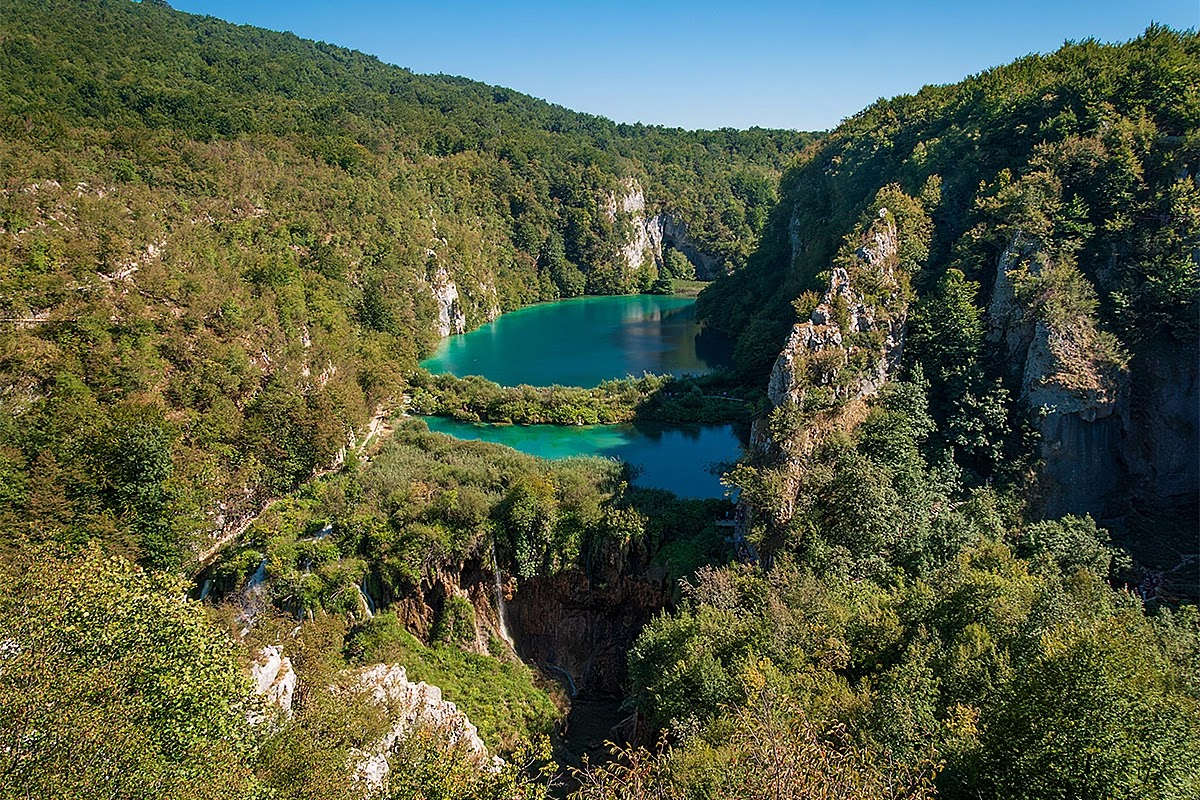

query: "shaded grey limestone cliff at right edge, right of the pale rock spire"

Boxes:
[988, 231, 1200, 519]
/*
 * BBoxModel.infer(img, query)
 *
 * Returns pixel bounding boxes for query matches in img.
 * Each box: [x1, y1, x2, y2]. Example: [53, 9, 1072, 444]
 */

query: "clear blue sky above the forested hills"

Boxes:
[172, 0, 1200, 130]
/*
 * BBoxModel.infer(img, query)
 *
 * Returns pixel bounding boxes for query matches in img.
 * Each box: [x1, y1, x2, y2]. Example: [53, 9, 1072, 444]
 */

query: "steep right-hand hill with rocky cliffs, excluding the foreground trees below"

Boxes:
[701, 28, 1200, 551]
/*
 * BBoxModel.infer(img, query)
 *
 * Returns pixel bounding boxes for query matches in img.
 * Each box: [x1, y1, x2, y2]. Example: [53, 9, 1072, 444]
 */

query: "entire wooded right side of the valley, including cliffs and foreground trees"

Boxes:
[628, 28, 1200, 800]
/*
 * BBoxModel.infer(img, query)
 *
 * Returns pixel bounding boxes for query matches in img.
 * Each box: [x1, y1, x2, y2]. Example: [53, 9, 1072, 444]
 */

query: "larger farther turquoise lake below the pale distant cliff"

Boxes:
[421, 295, 733, 387]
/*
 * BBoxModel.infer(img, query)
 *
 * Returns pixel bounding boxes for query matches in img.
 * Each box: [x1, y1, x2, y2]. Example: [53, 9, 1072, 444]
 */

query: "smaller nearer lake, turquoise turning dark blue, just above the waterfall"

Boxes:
[422, 416, 742, 498]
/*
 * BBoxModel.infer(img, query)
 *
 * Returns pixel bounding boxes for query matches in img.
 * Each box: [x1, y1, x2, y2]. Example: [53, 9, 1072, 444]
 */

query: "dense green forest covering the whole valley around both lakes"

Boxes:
[0, 0, 1200, 800]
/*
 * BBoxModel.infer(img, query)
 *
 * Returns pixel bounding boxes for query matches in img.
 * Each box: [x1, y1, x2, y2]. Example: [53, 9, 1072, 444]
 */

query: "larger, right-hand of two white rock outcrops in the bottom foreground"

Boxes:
[356, 664, 498, 790]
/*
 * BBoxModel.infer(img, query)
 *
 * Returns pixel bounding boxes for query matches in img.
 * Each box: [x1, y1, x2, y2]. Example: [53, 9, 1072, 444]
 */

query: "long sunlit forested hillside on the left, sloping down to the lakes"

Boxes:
[0, 0, 811, 567]
